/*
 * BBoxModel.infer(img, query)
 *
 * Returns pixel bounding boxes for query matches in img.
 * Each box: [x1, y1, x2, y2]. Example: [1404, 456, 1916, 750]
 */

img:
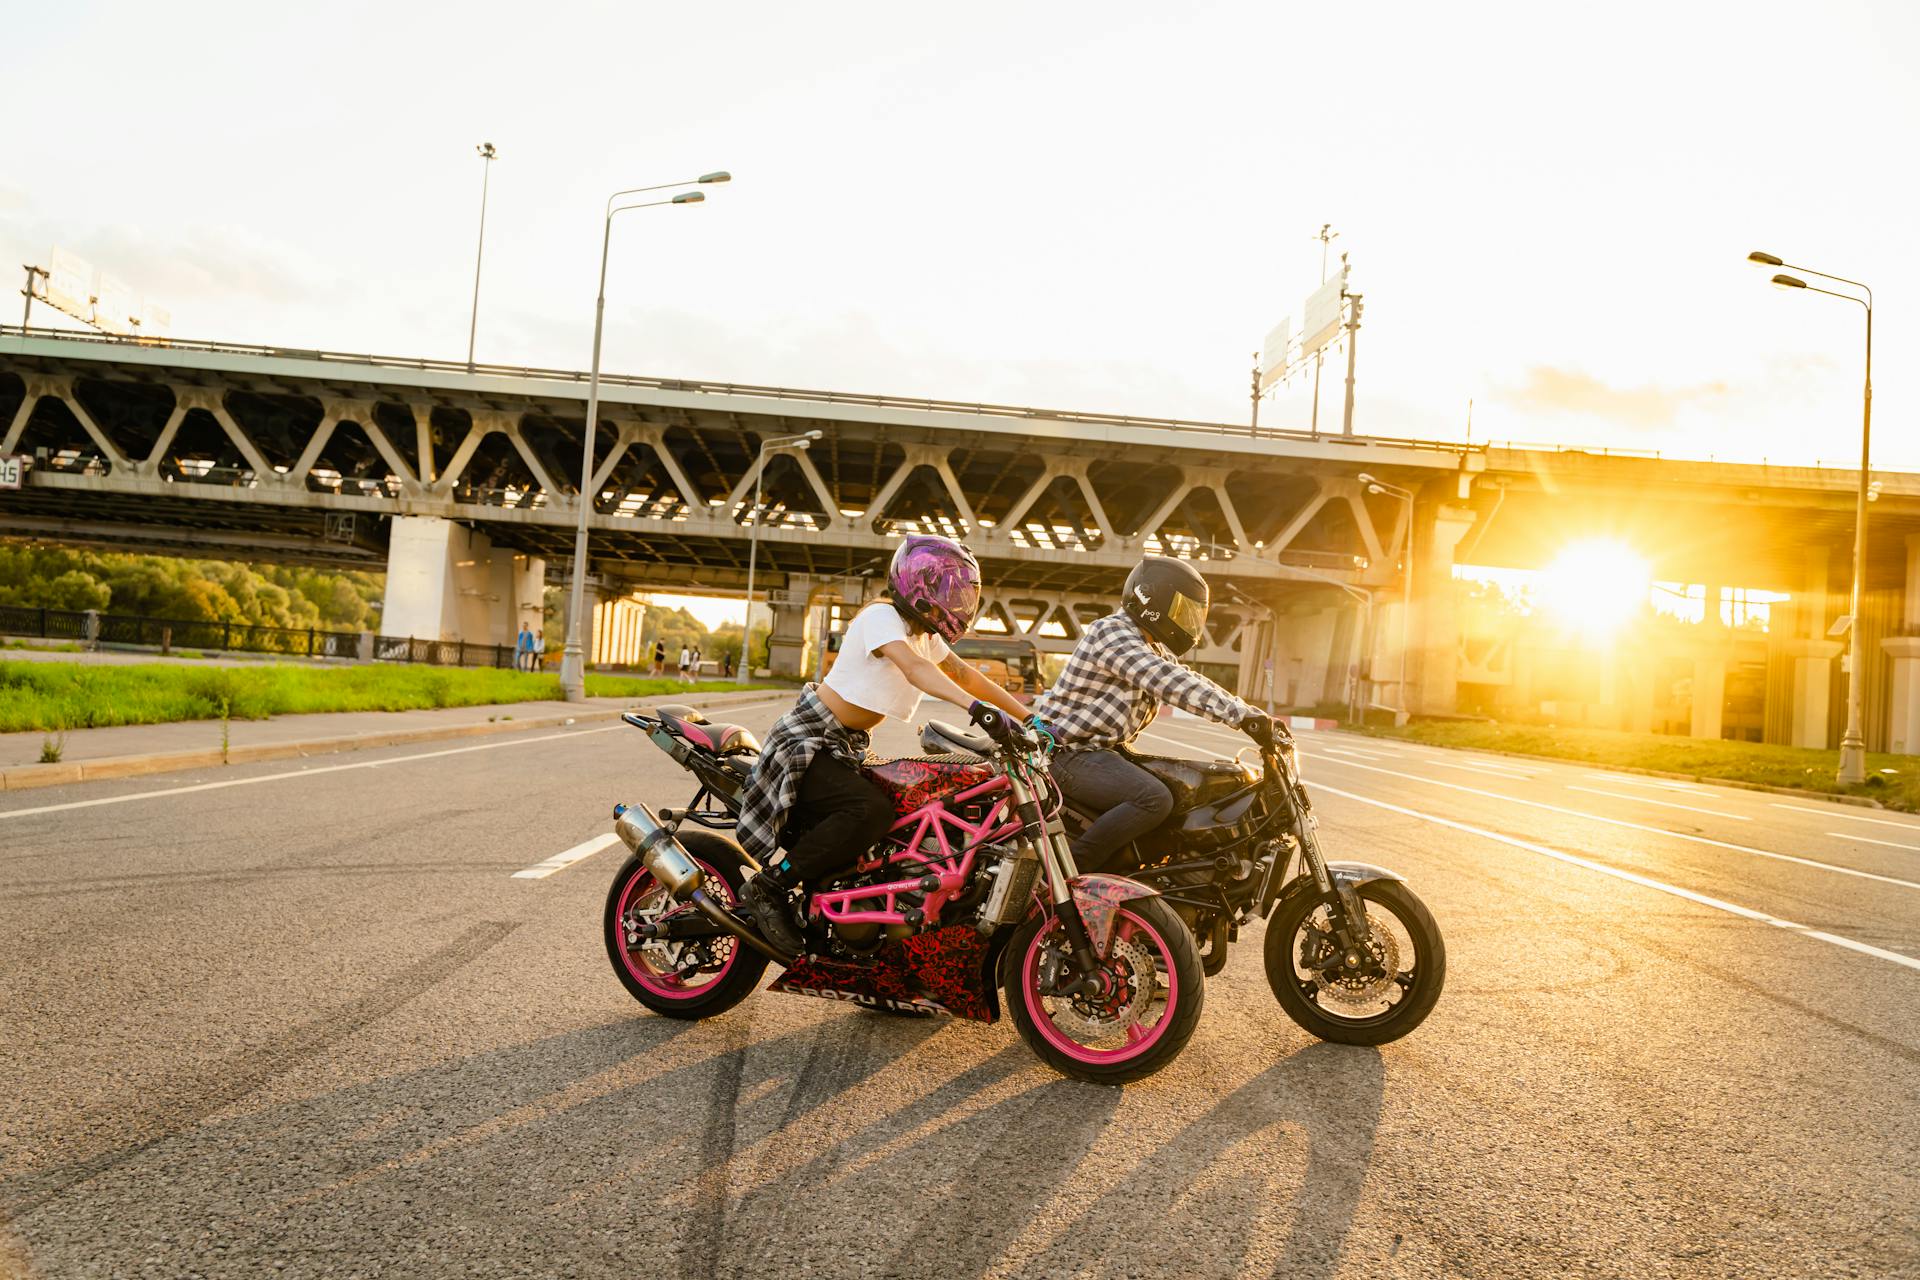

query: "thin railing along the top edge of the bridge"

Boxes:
[0, 324, 1486, 453]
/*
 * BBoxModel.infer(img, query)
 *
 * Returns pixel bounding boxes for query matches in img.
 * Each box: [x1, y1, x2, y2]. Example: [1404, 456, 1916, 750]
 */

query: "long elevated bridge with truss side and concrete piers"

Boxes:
[11, 328, 1920, 750]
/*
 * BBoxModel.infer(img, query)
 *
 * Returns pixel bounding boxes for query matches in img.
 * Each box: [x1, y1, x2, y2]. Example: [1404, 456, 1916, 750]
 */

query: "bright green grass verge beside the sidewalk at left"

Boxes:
[0, 662, 778, 733]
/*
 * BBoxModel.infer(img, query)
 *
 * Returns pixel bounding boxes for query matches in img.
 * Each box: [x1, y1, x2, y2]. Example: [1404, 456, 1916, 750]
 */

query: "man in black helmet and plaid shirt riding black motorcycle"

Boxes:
[1033, 557, 1279, 871]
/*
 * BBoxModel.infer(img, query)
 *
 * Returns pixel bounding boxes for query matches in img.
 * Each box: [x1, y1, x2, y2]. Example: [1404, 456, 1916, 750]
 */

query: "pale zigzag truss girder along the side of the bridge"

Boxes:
[0, 358, 1405, 583]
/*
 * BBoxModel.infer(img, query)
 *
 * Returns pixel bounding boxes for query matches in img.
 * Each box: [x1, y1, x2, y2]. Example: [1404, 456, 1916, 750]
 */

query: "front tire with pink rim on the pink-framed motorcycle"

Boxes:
[1000, 898, 1206, 1084]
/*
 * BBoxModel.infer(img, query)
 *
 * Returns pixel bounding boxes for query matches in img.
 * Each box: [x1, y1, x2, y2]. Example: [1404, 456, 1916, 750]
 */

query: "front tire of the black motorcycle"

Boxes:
[1265, 881, 1446, 1044]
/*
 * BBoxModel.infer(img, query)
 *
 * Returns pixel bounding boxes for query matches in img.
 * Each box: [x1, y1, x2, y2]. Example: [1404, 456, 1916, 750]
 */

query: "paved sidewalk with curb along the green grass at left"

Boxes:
[0, 689, 787, 791]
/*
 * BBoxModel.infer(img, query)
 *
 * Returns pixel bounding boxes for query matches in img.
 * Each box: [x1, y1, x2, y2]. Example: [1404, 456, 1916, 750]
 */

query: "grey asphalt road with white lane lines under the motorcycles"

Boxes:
[0, 702, 1920, 1280]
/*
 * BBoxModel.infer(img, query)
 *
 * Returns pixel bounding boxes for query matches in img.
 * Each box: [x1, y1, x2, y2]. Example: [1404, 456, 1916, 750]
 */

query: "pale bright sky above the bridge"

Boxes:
[0, 0, 1920, 485]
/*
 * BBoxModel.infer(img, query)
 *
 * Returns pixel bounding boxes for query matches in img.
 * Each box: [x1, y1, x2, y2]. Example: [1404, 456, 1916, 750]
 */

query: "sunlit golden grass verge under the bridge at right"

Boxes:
[1363, 720, 1920, 812]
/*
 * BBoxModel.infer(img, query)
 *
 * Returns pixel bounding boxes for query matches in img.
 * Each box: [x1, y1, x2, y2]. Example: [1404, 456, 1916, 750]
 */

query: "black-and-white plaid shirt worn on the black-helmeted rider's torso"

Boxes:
[1033, 610, 1260, 750]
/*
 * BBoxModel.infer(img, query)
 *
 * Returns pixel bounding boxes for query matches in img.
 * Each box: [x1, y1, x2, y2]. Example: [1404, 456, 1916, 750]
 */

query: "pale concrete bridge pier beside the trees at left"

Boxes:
[380, 516, 547, 645]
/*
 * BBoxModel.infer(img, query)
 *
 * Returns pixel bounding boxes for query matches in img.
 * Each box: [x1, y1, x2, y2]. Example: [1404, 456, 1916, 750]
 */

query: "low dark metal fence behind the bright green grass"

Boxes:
[0, 604, 513, 668]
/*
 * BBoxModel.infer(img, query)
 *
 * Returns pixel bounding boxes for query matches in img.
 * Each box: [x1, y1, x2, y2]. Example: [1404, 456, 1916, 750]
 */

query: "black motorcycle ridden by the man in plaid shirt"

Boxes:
[920, 720, 1446, 1044]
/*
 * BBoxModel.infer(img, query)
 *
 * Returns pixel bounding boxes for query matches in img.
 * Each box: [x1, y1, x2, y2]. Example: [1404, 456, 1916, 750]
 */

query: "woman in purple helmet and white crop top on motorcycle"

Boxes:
[735, 533, 1027, 954]
